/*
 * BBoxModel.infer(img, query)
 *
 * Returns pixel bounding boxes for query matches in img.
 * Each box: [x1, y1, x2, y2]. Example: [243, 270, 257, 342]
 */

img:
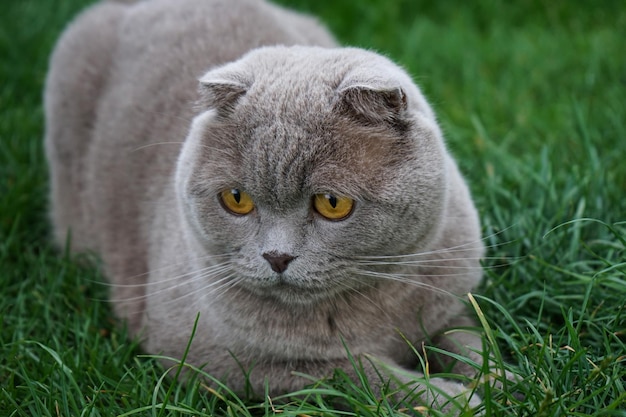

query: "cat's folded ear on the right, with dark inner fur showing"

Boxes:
[339, 85, 408, 130]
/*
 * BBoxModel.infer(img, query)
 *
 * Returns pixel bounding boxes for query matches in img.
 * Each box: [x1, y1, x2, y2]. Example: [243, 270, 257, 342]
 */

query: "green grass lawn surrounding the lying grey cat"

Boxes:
[0, 0, 626, 417]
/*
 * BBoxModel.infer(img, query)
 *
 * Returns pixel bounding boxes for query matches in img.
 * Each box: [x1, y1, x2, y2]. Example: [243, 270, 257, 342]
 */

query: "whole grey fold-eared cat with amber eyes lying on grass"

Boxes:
[45, 0, 484, 410]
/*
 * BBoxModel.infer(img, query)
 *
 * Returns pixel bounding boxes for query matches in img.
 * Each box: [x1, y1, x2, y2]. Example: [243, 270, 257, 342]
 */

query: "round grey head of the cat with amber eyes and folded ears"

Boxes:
[177, 48, 445, 303]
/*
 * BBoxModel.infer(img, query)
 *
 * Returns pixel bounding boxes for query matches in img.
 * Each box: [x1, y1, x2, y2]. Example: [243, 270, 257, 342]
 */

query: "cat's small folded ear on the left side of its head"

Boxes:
[199, 69, 250, 116]
